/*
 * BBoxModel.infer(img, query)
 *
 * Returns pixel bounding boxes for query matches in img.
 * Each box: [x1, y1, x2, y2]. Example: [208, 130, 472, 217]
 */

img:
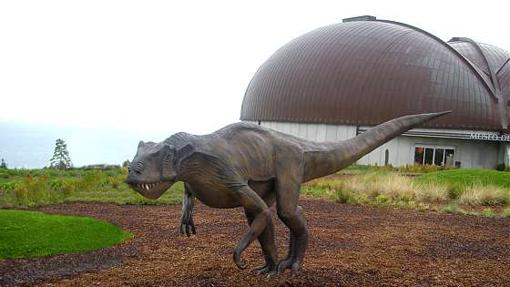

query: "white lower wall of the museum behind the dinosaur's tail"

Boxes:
[251, 122, 502, 168]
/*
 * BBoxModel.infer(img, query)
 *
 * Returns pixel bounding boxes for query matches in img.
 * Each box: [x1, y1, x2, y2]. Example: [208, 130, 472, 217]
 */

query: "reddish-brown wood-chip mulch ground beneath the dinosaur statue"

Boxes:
[0, 199, 510, 286]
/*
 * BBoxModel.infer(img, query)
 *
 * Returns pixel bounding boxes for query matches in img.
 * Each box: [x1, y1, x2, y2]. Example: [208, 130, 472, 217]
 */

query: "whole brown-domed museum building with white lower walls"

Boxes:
[241, 16, 510, 168]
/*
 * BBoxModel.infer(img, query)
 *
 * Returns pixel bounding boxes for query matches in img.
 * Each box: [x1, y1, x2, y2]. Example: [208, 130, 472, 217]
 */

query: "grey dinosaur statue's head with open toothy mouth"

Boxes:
[126, 141, 177, 199]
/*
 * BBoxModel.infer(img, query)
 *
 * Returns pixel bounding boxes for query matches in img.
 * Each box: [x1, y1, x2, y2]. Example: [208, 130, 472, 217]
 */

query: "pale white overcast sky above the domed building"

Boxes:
[0, 0, 510, 134]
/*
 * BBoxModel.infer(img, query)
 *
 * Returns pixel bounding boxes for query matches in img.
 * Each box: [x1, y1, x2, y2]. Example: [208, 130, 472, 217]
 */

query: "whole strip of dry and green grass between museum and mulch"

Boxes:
[303, 169, 510, 217]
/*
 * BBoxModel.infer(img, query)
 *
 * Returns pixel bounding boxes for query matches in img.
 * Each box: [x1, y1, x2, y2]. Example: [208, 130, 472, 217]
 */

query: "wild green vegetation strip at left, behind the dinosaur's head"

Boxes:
[0, 168, 184, 208]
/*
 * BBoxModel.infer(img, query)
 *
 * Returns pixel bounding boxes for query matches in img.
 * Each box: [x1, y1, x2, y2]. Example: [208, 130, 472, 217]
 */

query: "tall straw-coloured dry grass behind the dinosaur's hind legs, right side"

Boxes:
[304, 171, 510, 214]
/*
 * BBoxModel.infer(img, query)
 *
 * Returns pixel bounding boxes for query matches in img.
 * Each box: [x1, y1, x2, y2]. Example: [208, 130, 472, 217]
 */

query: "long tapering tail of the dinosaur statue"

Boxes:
[303, 112, 449, 182]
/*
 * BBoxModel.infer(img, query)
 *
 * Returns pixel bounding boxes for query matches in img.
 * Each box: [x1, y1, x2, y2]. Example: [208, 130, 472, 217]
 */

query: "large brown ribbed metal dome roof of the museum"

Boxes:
[241, 18, 510, 130]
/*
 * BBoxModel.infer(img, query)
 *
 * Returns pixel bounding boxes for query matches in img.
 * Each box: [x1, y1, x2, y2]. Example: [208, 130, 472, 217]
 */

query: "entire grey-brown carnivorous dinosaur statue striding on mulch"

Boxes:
[126, 112, 449, 275]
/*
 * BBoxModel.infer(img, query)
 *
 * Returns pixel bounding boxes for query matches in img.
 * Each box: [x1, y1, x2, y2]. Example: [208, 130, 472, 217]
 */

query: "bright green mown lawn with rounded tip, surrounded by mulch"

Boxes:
[0, 210, 132, 259]
